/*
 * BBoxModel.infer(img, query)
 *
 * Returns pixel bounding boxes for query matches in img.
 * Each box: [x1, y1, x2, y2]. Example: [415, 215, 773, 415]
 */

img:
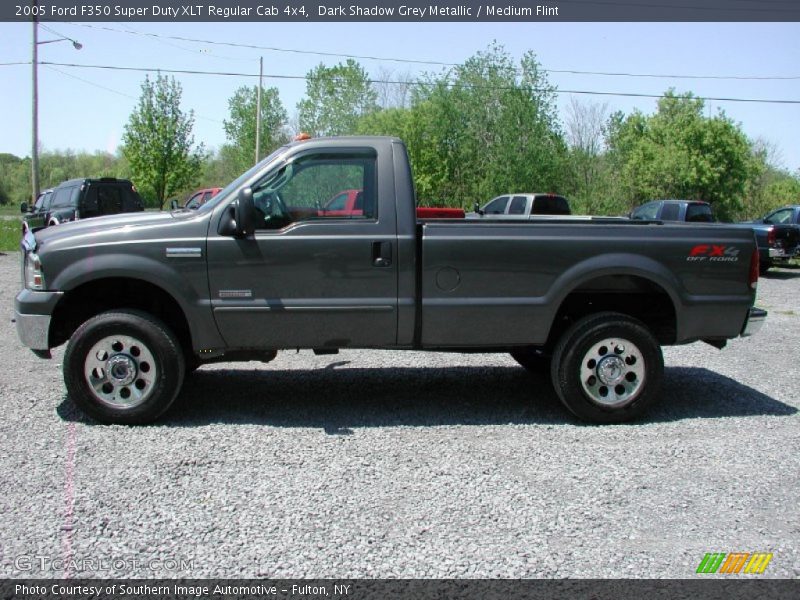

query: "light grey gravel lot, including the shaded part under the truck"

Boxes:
[0, 253, 800, 578]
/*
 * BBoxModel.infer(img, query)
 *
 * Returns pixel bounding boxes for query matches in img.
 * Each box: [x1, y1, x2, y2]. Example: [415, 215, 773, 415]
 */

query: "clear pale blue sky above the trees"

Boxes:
[0, 22, 800, 171]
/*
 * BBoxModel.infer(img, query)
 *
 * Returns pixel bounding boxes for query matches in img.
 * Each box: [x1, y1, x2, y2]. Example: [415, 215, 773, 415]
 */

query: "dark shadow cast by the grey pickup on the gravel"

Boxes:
[58, 367, 797, 428]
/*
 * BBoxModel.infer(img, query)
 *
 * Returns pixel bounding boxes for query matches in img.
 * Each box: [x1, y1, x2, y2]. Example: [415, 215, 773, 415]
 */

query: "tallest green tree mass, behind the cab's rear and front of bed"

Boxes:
[359, 45, 566, 207]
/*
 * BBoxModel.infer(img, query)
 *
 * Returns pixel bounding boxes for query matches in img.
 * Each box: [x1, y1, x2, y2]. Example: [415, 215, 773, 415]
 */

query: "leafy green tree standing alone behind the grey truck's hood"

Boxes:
[122, 74, 205, 206]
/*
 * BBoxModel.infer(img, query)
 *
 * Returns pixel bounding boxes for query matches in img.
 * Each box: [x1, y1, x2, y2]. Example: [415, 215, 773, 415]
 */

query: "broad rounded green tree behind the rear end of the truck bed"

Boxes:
[608, 90, 752, 219]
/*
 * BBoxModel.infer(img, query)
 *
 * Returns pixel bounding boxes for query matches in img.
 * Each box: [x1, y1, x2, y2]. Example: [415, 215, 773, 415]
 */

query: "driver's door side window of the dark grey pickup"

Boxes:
[253, 154, 378, 229]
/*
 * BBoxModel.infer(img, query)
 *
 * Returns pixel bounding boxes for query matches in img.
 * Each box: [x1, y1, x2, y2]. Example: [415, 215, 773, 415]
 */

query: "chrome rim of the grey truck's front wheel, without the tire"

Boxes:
[83, 335, 158, 409]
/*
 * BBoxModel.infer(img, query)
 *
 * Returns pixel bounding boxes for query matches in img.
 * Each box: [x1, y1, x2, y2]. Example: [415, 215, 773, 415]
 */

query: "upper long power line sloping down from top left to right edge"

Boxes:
[70, 22, 800, 81]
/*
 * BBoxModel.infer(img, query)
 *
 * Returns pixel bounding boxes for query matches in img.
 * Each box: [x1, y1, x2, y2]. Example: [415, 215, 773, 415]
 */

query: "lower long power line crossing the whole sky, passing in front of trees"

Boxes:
[34, 61, 800, 104]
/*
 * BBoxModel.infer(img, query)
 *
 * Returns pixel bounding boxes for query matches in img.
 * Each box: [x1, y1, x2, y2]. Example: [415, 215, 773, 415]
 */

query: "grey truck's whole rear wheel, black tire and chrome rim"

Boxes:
[551, 313, 664, 423]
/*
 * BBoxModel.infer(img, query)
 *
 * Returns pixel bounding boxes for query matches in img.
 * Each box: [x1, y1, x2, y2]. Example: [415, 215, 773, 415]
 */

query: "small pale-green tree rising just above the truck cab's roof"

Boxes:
[297, 59, 378, 136]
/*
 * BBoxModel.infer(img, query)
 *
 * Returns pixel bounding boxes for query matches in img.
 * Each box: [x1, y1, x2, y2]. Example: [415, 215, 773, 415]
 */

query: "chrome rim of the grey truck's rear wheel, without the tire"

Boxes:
[580, 338, 645, 408]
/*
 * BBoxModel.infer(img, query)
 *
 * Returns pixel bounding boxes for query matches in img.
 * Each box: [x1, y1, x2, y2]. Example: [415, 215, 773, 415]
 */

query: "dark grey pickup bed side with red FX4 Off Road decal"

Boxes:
[419, 218, 753, 347]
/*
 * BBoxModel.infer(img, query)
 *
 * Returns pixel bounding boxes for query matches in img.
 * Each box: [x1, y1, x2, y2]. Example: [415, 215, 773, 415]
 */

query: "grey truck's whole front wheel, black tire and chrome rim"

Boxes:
[64, 310, 185, 424]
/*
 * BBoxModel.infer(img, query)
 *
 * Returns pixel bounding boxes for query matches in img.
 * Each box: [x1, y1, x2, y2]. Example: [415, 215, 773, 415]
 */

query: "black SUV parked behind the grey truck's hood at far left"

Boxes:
[20, 177, 144, 231]
